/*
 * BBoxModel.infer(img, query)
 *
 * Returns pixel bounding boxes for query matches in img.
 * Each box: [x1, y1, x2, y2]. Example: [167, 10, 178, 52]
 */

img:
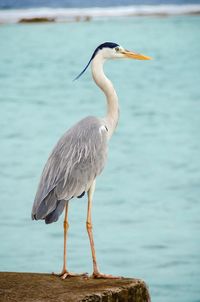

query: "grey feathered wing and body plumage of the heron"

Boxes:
[32, 117, 107, 223]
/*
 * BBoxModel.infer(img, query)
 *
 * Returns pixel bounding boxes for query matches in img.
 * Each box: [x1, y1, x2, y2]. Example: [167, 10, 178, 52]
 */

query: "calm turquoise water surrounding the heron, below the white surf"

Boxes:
[0, 16, 200, 302]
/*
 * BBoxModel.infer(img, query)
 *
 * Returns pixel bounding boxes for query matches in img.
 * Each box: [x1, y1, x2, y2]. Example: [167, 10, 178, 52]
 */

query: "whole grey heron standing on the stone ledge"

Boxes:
[32, 42, 151, 279]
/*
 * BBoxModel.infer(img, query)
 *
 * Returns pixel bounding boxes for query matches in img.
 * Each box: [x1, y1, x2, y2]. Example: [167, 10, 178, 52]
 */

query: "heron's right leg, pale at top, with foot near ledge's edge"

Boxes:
[86, 181, 120, 279]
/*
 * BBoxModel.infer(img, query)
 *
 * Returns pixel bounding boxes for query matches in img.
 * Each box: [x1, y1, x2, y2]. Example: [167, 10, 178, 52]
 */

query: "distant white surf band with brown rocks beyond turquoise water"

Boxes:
[0, 4, 200, 24]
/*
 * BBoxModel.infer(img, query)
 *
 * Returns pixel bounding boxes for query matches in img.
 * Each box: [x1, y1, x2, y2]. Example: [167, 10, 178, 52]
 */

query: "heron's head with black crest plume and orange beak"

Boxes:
[74, 42, 151, 80]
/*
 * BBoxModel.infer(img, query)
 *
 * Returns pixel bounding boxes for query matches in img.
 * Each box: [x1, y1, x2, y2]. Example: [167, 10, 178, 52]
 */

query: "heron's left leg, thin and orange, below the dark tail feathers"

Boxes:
[53, 201, 87, 279]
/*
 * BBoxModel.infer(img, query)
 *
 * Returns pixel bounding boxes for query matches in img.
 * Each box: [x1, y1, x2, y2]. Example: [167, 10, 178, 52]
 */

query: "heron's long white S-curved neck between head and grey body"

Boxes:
[92, 55, 119, 138]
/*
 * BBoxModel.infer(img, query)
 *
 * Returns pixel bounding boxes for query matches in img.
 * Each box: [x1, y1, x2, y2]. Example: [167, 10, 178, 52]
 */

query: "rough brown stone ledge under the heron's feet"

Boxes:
[0, 272, 150, 302]
